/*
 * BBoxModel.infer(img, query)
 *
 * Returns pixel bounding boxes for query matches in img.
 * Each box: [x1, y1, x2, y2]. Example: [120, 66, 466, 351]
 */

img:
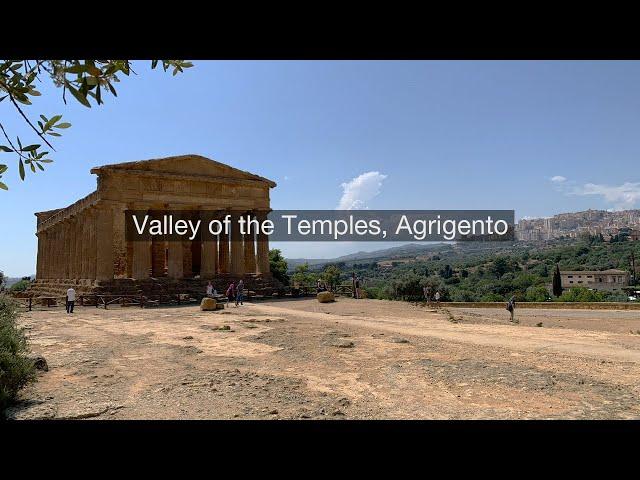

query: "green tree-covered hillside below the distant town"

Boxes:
[353, 237, 640, 302]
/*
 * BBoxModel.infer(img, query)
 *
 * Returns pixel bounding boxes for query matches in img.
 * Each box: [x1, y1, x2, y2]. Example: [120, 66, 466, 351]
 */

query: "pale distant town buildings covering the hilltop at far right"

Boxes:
[515, 209, 640, 241]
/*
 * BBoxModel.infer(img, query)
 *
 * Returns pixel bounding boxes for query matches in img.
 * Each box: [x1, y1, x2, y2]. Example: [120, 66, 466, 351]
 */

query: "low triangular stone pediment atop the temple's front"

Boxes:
[91, 155, 276, 188]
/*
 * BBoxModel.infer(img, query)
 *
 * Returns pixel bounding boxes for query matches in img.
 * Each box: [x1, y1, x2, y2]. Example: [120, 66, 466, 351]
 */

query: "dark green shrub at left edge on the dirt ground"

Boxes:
[0, 295, 35, 412]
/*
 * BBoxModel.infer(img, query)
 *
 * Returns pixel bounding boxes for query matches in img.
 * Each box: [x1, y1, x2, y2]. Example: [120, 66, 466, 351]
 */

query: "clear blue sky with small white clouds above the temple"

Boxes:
[0, 61, 640, 276]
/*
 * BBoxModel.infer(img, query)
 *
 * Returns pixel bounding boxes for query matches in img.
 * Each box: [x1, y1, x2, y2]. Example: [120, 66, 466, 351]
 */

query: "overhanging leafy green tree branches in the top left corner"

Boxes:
[0, 60, 193, 190]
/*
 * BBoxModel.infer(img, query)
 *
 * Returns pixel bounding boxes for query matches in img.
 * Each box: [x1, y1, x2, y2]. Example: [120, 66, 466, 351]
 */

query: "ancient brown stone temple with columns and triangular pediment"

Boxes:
[33, 155, 276, 294]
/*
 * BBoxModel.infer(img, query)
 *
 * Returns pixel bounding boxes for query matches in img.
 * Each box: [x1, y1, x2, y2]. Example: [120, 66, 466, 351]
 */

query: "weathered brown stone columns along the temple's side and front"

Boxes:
[36, 204, 269, 280]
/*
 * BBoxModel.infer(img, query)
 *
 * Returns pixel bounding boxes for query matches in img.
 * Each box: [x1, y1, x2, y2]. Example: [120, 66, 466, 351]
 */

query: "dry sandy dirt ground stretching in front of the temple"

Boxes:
[8, 298, 640, 419]
